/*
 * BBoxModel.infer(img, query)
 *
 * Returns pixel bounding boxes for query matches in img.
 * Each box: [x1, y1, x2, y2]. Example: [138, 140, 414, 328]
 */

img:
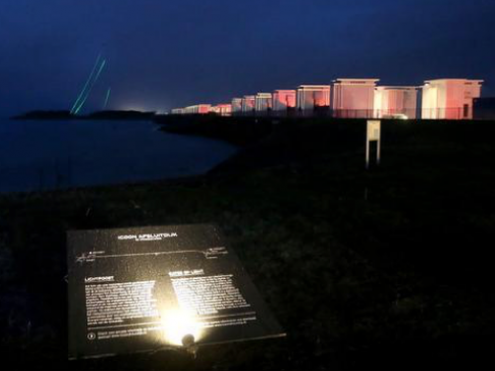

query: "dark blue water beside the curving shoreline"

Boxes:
[0, 120, 236, 192]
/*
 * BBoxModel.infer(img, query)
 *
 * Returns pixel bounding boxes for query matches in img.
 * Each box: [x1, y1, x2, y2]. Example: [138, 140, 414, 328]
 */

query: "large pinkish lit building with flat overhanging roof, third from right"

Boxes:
[332, 79, 380, 118]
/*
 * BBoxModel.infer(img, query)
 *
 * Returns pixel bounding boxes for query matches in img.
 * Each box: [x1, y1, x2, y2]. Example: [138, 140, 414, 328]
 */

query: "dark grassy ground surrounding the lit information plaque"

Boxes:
[0, 121, 495, 370]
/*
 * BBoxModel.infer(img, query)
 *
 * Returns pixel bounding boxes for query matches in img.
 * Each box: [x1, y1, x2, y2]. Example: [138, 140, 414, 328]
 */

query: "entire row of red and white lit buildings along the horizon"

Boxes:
[171, 79, 483, 119]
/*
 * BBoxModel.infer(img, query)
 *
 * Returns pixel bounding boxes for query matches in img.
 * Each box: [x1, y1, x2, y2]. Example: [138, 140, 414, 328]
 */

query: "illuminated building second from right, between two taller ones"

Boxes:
[374, 86, 418, 119]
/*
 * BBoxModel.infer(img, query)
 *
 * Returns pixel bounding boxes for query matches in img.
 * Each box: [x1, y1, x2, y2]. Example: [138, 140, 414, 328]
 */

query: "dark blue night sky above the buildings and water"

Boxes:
[0, 0, 495, 116]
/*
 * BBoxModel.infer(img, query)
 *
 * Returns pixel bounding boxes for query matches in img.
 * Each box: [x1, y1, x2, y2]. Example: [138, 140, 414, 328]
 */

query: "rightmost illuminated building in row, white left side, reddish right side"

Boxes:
[421, 79, 483, 120]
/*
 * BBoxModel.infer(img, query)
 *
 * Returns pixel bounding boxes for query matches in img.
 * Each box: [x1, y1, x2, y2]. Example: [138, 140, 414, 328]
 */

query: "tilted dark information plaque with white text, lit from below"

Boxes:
[67, 225, 285, 359]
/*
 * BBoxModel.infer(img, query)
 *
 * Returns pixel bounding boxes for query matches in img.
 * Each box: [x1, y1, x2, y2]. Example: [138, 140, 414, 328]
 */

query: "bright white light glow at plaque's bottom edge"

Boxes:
[162, 310, 202, 346]
